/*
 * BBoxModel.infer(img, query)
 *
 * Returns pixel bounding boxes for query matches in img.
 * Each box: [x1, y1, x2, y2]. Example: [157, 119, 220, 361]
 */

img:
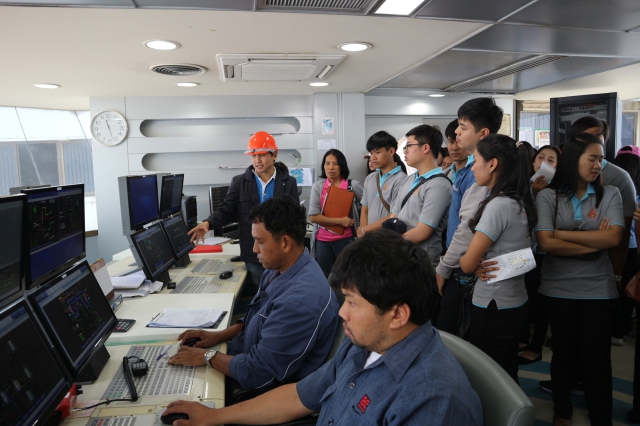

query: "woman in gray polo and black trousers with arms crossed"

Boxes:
[536, 133, 624, 425]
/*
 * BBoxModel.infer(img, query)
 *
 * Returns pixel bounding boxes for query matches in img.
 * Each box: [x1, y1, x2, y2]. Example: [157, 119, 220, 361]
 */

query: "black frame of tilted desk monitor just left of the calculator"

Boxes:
[27, 260, 118, 380]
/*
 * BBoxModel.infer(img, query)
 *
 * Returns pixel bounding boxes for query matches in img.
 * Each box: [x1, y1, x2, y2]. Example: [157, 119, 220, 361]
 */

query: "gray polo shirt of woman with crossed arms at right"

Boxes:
[536, 185, 624, 299]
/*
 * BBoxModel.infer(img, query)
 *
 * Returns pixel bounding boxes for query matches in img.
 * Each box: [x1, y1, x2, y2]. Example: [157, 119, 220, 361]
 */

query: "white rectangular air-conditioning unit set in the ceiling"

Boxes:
[216, 54, 346, 82]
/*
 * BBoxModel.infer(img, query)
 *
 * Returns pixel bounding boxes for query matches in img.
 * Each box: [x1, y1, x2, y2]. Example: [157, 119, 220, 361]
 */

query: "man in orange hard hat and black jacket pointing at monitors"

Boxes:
[189, 131, 300, 287]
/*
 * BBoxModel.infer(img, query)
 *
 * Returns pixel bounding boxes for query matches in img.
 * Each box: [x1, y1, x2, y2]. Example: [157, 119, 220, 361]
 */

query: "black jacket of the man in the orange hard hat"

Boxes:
[205, 164, 300, 263]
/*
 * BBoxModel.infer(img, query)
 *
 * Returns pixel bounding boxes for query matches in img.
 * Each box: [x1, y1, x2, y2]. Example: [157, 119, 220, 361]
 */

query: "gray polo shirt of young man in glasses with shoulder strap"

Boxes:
[391, 167, 453, 267]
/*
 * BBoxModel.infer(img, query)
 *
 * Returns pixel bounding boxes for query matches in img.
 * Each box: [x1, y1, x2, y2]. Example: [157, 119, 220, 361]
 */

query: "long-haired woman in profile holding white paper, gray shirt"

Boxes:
[460, 134, 537, 382]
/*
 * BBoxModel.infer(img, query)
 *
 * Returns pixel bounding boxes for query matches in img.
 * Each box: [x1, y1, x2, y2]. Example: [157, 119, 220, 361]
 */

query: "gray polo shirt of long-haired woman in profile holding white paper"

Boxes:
[472, 196, 531, 309]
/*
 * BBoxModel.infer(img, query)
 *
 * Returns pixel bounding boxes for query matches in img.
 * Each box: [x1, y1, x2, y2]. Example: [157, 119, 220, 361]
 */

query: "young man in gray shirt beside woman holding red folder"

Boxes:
[358, 130, 407, 238]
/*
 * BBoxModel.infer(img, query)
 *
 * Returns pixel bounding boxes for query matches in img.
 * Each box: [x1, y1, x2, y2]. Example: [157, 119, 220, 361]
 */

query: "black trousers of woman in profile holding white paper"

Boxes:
[470, 300, 527, 383]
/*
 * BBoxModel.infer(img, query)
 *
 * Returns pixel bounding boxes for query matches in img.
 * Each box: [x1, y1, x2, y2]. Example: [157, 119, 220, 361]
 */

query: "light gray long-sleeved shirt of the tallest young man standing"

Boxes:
[436, 183, 489, 278]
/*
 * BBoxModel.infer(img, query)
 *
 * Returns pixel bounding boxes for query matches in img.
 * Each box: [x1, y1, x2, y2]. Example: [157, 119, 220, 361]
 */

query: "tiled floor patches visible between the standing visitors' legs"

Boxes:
[518, 335, 635, 426]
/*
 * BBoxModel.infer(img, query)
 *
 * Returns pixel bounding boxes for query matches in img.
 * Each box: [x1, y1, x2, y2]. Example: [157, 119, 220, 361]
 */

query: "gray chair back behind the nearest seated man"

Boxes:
[440, 331, 535, 426]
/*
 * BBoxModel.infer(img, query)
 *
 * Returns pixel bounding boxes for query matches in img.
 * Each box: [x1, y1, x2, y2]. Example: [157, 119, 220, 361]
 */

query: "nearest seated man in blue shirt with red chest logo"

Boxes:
[165, 230, 483, 426]
